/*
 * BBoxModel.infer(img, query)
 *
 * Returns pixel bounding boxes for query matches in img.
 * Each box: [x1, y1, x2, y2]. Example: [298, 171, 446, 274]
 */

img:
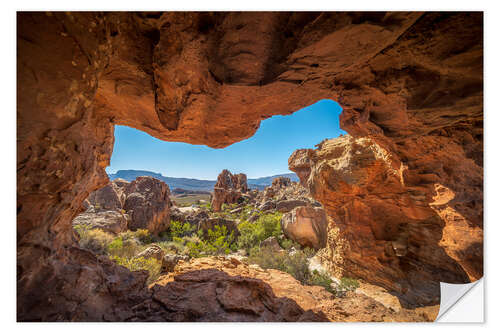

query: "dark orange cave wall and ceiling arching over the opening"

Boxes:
[17, 12, 483, 321]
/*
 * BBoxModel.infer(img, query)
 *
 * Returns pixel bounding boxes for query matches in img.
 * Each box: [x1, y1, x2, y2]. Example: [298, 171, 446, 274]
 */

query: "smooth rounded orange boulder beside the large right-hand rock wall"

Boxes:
[281, 206, 328, 250]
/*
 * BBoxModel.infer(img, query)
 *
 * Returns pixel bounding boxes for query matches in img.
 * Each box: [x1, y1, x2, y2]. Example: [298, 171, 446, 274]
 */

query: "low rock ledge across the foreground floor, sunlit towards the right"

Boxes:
[144, 258, 437, 321]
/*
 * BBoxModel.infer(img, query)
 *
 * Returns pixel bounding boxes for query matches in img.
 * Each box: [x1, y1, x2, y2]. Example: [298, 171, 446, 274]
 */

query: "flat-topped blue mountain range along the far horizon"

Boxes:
[108, 170, 299, 191]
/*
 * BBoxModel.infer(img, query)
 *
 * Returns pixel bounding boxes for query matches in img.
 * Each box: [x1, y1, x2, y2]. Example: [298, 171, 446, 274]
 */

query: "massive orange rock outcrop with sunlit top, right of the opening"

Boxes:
[289, 136, 483, 306]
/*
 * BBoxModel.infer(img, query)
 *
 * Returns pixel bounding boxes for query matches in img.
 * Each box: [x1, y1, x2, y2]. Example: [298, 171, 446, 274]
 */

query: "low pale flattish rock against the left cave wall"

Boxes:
[72, 210, 130, 234]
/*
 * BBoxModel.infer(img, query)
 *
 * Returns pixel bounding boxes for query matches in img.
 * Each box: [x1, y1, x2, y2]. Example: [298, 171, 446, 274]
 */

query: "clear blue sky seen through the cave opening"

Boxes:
[106, 100, 345, 180]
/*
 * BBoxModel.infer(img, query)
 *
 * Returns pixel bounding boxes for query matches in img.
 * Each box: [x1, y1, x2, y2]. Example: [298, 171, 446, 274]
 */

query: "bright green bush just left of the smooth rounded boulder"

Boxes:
[238, 212, 283, 251]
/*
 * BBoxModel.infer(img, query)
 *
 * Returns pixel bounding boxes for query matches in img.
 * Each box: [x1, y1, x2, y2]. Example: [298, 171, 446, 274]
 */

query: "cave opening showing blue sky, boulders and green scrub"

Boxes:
[72, 100, 345, 298]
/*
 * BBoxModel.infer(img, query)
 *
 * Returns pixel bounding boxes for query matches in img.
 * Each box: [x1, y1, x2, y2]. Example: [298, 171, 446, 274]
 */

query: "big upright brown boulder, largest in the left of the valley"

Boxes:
[123, 177, 171, 234]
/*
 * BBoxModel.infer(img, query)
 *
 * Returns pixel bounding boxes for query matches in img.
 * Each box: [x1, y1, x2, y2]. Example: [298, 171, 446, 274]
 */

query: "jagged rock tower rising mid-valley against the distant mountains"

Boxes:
[212, 170, 248, 212]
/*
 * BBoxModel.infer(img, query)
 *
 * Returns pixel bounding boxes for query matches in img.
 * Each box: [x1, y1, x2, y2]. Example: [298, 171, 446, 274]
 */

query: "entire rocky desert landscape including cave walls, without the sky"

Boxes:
[17, 12, 483, 322]
